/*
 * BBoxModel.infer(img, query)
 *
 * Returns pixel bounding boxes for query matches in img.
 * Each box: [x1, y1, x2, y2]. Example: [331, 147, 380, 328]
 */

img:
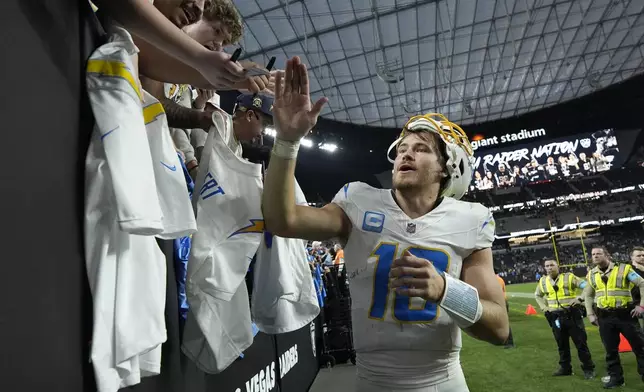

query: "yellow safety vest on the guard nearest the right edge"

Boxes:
[588, 264, 634, 309]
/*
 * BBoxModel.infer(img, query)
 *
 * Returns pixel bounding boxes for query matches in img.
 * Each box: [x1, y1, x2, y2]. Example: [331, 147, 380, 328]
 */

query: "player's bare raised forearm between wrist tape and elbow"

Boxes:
[262, 154, 296, 237]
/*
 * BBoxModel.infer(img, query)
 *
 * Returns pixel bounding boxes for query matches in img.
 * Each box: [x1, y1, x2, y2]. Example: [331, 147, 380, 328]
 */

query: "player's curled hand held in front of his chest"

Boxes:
[389, 251, 445, 302]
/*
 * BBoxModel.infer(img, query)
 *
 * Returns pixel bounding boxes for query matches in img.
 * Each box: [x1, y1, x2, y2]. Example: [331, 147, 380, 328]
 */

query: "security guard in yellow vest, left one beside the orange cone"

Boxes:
[534, 260, 595, 380]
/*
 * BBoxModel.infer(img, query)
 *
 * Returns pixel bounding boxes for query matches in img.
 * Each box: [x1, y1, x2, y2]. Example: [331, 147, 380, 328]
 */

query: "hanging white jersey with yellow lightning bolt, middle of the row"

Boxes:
[182, 119, 264, 373]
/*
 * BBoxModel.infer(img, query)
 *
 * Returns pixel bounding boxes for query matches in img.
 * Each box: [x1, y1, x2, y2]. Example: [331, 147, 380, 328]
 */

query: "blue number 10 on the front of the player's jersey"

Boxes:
[369, 242, 449, 323]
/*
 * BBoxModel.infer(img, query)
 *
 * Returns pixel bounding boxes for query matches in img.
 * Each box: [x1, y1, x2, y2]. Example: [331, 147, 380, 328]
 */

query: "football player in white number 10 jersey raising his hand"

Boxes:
[263, 57, 509, 392]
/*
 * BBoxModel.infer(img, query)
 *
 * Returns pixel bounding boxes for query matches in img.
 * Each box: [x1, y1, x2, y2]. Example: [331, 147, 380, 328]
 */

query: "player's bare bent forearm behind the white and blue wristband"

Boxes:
[465, 299, 510, 345]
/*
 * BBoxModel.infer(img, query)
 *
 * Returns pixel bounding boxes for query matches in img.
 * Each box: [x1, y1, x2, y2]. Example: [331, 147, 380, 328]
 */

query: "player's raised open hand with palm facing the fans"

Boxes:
[273, 56, 327, 141]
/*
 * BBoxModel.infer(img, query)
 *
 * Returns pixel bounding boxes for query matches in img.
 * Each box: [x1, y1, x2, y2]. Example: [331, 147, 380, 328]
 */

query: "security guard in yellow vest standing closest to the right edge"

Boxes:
[584, 246, 644, 389]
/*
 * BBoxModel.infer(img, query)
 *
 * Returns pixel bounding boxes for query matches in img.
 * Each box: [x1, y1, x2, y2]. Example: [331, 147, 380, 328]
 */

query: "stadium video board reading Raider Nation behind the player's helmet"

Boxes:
[470, 129, 626, 190]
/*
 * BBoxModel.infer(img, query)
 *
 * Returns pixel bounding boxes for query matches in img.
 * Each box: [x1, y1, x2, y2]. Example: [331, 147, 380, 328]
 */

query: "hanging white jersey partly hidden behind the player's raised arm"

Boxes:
[251, 181, 320, 334]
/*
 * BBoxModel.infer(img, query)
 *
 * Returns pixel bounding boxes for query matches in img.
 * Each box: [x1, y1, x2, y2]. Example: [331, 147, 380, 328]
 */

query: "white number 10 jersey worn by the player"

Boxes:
[333, 183, 494, 390]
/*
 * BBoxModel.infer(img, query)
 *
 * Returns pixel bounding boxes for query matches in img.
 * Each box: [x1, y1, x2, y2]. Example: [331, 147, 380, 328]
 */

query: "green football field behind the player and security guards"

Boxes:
[461, 283, 644, 392]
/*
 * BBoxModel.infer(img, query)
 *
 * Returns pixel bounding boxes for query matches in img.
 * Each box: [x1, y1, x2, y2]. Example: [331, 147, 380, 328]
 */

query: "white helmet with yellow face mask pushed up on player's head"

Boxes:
[387, 113, 474, 199]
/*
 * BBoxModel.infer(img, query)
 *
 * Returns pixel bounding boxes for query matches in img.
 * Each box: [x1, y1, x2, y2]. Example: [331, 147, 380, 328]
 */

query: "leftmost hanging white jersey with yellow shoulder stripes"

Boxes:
[85, 27, 196, 392]
